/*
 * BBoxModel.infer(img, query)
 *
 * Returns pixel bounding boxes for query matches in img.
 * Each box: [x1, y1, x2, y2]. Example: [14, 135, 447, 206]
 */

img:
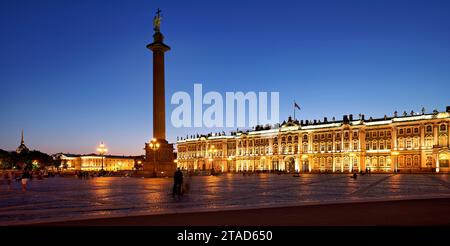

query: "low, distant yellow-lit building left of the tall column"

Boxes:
[53, 153, 142, 171]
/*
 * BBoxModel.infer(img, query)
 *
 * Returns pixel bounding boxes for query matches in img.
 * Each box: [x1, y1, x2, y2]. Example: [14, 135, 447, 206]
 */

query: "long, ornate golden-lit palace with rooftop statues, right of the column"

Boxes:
[177, 107, 450, 173]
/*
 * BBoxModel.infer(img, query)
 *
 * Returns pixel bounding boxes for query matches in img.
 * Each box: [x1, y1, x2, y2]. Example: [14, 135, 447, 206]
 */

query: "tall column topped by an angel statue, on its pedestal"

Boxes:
[144, 9, 176, 176]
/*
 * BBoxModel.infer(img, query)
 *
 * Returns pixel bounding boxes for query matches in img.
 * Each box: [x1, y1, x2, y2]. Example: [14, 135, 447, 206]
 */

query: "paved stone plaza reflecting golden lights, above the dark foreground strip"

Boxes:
[0, 174, 450, 225]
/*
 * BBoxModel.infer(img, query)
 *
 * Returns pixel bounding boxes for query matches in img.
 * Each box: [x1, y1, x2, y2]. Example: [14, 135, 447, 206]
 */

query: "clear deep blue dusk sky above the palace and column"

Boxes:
[0, 0, 450, 155]
